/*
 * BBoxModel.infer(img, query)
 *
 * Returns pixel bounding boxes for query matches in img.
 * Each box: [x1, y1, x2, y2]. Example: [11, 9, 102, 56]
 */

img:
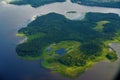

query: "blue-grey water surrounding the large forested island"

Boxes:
[0, 0, 120, 80]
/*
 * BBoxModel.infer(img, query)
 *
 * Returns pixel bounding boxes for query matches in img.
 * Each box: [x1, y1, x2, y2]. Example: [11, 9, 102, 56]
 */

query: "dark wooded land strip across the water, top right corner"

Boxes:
[71, 0, 120, 8]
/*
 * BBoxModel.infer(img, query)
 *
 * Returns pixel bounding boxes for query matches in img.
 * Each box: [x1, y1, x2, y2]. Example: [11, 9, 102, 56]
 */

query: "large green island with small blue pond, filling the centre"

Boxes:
[16, 12, 120, 78]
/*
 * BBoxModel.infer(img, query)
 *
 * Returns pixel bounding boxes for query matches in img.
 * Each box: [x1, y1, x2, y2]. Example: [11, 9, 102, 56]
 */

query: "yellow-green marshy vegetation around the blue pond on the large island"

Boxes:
[42, 41, 117, 77]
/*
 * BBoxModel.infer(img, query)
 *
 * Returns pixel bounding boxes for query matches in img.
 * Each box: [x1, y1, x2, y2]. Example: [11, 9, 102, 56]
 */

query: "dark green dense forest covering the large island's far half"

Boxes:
[16, 13, 120, 57]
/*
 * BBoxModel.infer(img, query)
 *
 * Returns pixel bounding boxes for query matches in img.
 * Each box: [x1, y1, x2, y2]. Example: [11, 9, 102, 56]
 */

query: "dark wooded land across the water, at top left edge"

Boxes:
[9, 0, 65, 8]
